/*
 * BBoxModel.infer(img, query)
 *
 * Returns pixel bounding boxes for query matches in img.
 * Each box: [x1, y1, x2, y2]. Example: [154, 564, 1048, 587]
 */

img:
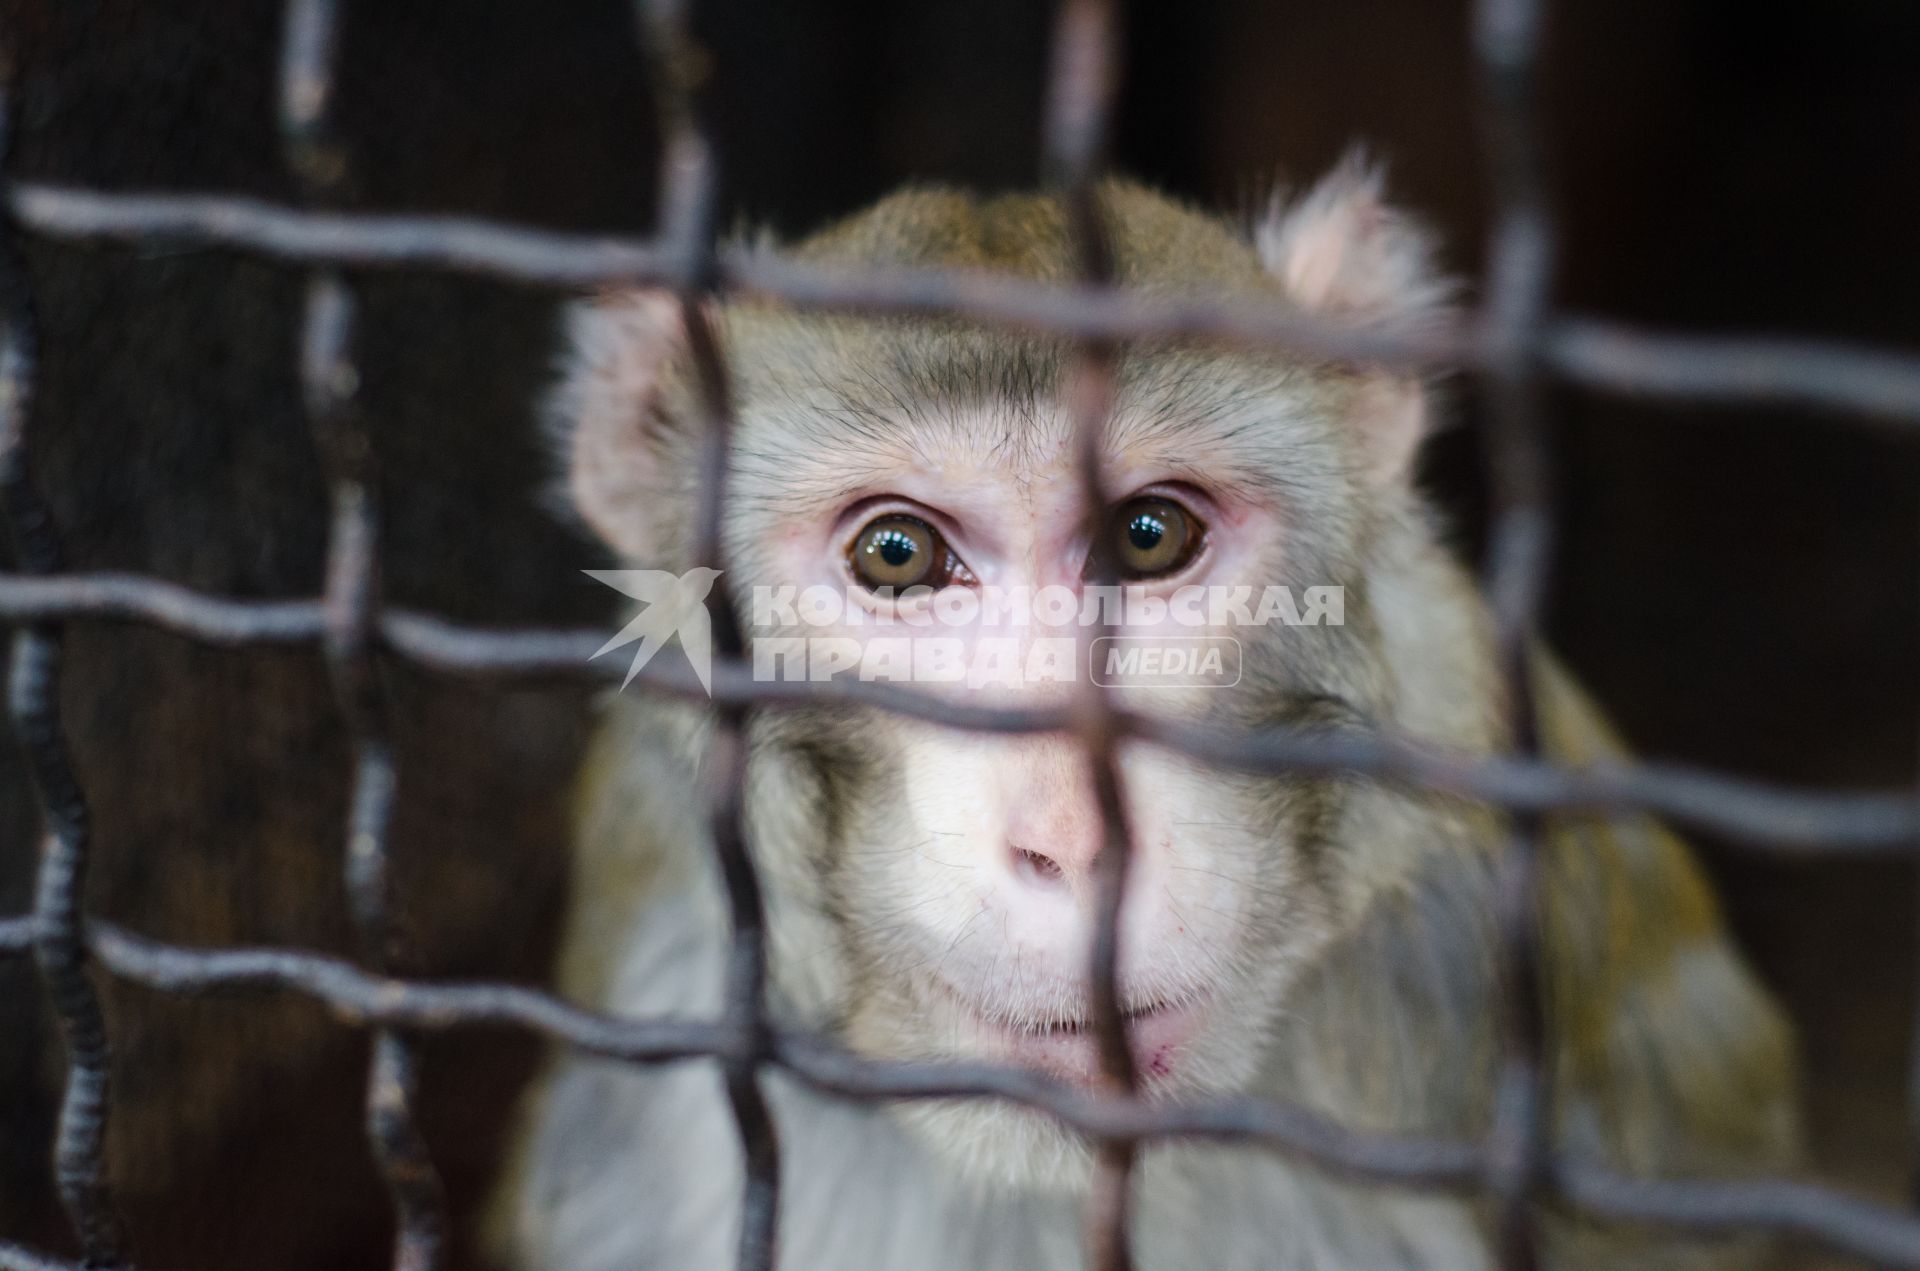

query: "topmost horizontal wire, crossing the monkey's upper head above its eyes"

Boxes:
[12, 182, 1920, 428]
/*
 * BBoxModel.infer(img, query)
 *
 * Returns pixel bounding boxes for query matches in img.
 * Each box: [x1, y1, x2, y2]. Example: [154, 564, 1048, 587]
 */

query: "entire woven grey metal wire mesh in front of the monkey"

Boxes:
[0, 0, 1920, 1271]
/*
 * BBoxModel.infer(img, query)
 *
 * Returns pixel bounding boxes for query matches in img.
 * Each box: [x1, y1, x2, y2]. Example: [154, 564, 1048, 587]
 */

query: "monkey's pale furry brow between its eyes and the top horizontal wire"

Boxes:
[702, 326, 1354, 526]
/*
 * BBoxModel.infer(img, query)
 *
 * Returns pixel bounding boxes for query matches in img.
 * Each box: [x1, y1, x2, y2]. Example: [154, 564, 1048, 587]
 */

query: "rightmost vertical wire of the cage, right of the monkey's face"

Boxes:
[1473, 0, 1555, 1271]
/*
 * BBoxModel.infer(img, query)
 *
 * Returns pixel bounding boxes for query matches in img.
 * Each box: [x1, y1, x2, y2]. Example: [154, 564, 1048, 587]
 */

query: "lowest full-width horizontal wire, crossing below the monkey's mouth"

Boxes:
[0, 918, 1920, 1271]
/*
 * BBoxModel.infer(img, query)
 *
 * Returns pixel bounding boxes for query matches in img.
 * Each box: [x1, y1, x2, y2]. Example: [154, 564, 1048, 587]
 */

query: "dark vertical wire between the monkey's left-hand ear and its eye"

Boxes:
[636, 0, 780, 1271]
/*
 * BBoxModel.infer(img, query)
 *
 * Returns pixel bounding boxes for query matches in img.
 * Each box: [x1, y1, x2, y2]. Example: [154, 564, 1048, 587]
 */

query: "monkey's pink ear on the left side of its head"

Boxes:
[549, 290, 685, 561]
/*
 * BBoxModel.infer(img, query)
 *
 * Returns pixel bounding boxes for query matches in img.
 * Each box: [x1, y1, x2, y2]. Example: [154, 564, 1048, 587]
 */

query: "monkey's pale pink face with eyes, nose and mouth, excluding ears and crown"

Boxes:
[732, 361, 1367, 1179]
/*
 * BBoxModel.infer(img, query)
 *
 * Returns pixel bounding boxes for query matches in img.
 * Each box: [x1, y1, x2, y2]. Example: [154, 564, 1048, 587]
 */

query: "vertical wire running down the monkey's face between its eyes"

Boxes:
[1043, 0, 1139, 1271]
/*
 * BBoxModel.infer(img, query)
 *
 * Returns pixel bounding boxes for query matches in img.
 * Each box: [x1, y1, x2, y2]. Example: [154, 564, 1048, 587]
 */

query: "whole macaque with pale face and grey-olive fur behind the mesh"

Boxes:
[493, 159, 1799, 1271]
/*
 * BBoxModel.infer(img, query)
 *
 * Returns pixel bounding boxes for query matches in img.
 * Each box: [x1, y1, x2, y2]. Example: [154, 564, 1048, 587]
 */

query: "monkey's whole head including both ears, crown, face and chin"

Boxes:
[555, 169, 1442, 1179]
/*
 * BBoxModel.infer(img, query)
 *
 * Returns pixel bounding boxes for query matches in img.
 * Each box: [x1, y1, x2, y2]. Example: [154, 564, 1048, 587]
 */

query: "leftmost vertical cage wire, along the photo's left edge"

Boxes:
[0, 44, 123, 1267]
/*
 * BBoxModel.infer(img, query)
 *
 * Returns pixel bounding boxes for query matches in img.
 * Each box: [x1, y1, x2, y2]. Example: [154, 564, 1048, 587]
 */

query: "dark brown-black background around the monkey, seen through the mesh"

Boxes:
[0, 0, 1920, 1271]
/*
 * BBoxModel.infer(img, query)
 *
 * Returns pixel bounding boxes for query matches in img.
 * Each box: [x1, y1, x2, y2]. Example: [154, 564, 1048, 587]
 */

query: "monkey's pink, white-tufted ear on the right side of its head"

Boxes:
[1254, 150, 1455, 484]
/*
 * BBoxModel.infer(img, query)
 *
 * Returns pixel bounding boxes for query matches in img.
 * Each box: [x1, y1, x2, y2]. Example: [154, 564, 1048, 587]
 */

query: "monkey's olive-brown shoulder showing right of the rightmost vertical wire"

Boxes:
[1534, 659, 1799, 1173]
